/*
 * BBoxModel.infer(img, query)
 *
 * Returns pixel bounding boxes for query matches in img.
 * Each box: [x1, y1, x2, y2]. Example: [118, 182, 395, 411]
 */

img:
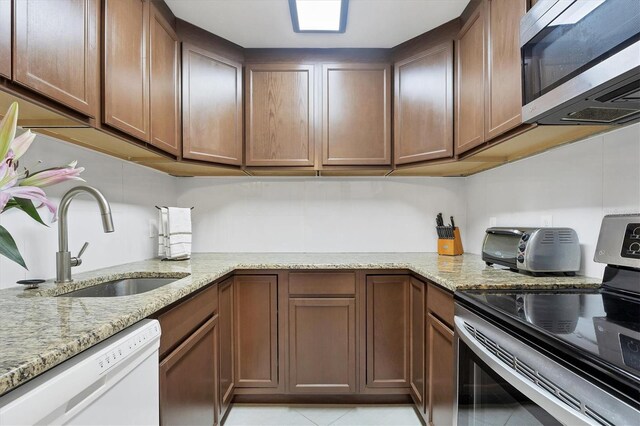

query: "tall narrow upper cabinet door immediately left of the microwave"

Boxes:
[485, 0, 527, 140]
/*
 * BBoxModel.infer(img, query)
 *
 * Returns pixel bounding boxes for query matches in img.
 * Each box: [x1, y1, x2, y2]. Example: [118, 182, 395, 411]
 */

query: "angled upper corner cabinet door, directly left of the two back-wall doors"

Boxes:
[182, 43, 242, 165]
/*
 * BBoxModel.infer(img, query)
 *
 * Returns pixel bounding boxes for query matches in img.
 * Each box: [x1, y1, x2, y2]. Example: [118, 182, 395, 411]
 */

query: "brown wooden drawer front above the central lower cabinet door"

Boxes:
[289, 272, 356, 296]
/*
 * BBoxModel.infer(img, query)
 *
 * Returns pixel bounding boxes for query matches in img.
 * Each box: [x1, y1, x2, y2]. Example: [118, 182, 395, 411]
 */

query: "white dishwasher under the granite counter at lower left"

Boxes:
[0, 320, 160, 426]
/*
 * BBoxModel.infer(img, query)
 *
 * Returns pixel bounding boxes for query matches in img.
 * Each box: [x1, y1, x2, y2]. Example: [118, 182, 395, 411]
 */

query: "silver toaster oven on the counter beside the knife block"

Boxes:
[482, 227, 580, 275]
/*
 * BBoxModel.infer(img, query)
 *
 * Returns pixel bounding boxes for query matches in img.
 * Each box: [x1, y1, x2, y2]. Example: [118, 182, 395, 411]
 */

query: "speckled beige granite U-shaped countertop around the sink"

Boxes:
[0, 253, 601, 395]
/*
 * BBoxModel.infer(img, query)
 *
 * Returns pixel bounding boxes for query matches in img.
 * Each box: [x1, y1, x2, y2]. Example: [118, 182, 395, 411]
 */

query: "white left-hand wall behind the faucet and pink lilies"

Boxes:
[0, 135, 176, 288]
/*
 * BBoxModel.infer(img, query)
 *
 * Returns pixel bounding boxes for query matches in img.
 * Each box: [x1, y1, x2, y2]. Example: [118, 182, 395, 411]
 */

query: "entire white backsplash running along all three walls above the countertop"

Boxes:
[0, 124, 640, 288]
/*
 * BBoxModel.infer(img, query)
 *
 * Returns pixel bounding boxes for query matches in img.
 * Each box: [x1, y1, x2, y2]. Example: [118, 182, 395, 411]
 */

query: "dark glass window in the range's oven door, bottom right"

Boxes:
[458, 341, 561, 426]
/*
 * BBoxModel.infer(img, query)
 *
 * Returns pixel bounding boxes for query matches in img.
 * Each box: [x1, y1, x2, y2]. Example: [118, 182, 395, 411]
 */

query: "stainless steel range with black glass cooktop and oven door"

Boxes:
[455, 214, 640, 425]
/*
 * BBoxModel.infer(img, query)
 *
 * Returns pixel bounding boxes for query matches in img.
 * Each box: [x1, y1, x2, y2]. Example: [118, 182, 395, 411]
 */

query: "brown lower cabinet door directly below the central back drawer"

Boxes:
[289, 298, 356, 394]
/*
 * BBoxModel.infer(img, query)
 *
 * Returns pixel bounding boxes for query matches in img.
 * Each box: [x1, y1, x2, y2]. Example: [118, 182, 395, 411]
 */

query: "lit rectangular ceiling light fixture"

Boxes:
[289, 0, 349, 33]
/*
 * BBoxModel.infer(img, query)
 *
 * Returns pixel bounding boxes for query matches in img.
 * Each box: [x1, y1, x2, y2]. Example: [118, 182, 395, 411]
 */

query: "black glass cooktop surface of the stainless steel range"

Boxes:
[456, 289, 640, 398]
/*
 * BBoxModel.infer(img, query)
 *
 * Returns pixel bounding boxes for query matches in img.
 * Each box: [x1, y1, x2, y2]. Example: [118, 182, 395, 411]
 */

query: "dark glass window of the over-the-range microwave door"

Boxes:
[522, 0, 640, 104]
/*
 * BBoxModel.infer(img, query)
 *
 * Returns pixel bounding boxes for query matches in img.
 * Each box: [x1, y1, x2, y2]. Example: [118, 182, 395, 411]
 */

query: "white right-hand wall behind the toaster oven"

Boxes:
[464, 124, 640, 277]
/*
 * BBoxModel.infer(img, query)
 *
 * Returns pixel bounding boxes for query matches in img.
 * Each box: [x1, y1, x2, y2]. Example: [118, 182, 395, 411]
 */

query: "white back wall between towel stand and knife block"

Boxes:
[178, 178, 466, 252]
